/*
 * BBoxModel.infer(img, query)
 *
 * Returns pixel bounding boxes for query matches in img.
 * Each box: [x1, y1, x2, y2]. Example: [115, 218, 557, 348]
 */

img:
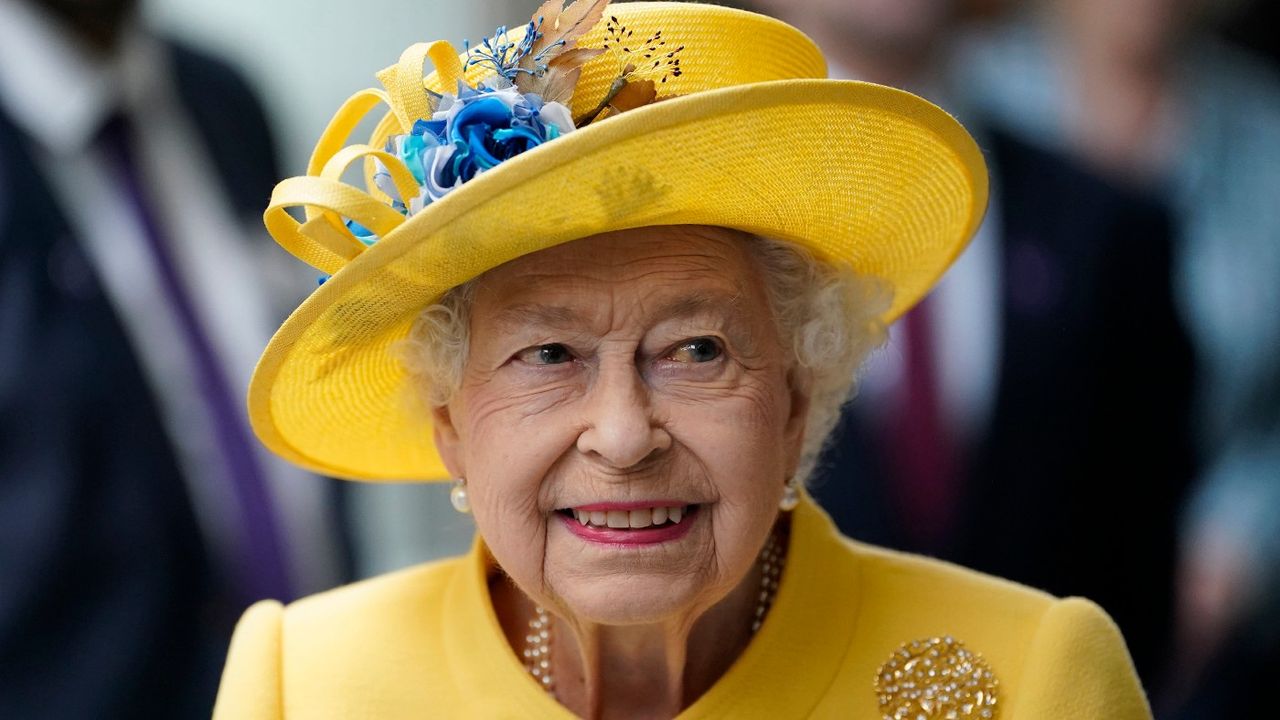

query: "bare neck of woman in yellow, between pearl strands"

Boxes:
[492, 520, 778, 719]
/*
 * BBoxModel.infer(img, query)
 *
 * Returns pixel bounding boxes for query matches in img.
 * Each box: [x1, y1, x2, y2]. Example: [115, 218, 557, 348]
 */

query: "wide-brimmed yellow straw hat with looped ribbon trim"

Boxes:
[248, 0, 987, 480]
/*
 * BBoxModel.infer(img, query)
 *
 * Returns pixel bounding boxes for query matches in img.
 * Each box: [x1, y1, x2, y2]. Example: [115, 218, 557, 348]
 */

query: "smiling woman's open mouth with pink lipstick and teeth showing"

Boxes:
[556, 502, 699, 546]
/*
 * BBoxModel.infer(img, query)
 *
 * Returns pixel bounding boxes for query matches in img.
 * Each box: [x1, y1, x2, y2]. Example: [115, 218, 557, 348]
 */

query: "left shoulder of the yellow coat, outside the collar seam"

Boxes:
[214, 556, 467, 720]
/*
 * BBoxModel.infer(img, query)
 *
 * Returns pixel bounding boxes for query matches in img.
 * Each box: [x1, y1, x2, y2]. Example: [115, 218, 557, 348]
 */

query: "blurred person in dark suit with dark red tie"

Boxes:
[753, 0, 1193, 685]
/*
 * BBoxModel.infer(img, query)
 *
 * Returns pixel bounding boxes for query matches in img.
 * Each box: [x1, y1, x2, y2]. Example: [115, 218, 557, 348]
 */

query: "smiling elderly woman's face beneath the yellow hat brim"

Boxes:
[436, 225, 808, 624]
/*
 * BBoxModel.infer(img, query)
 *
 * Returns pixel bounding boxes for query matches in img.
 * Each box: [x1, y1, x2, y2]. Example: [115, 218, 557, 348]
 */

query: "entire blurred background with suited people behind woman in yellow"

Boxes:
[0, 0, 1280, 719]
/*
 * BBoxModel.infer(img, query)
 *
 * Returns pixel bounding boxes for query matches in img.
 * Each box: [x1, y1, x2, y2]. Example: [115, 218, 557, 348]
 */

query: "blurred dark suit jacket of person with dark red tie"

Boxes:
[814, 126, 1192, 685]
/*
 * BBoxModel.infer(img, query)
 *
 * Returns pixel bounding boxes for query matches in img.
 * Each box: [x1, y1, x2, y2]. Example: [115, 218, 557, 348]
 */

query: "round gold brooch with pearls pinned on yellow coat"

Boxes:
[876, 637, 1000, 720]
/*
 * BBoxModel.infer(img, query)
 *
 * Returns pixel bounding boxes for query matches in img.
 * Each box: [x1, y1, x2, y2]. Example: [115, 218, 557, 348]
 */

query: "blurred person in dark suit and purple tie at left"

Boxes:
[0, 0, 342, 719]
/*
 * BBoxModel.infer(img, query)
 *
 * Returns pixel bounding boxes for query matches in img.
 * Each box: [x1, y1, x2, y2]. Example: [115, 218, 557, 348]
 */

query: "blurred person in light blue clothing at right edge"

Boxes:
[961, 0, 1280, 717]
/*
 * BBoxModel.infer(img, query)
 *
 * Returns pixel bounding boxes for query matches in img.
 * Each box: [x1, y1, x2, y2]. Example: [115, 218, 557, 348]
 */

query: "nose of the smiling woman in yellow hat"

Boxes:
[577, 364, 671, 468]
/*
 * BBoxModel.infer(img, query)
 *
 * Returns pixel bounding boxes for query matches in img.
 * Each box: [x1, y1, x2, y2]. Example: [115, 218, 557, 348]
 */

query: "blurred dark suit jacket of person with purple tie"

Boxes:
[0, 40, 278, 719]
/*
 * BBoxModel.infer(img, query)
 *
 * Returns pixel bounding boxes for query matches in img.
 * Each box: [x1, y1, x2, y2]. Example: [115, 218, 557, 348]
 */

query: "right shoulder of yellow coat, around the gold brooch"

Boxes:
[814, 539, 1151, 720]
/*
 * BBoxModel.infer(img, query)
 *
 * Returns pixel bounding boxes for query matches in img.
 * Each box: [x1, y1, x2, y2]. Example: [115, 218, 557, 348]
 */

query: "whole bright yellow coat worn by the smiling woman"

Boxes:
[214, 500, 1151, 720]
